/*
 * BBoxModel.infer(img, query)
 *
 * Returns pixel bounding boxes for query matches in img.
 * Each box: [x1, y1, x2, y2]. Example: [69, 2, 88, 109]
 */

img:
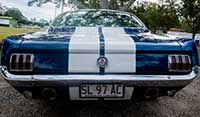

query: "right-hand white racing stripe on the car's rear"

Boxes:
[102, 27, 136, 73]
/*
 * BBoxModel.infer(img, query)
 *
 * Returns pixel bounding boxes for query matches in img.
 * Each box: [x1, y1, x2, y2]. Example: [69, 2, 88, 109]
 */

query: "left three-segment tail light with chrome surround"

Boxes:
[10, 53, 34, 71]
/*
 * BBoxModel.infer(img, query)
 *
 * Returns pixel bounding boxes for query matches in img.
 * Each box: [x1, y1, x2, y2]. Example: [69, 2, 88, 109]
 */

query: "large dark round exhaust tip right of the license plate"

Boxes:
[144, 88, 159, 99]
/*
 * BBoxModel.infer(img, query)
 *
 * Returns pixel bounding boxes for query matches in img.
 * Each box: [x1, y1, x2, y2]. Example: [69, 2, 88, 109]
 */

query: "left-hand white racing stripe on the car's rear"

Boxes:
[68, 27, 100, 73]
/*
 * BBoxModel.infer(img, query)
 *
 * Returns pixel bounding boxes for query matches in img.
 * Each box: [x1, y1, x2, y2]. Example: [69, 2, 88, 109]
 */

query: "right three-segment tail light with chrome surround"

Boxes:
[168, 55, 191, 72]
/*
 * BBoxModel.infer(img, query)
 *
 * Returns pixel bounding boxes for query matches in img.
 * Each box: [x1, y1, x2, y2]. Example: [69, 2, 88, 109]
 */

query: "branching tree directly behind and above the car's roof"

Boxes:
[28, 0, 136, 11]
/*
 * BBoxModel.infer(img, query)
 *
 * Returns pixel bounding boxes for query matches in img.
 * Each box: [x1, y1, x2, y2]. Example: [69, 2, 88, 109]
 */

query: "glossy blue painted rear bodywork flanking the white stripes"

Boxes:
[1, 27, 198, 74]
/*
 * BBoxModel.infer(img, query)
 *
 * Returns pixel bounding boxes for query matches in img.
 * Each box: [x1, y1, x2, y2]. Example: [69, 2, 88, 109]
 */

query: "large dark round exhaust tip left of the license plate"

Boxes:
[42, 88, 57, 100]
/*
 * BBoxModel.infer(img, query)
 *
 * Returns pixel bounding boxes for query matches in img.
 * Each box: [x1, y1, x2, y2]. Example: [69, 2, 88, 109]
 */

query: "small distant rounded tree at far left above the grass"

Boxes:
[4, 8, 27, 22]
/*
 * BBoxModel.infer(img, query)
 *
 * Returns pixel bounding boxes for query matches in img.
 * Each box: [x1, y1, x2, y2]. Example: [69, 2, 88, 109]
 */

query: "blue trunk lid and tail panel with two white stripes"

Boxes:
[9, 27, 182, 74]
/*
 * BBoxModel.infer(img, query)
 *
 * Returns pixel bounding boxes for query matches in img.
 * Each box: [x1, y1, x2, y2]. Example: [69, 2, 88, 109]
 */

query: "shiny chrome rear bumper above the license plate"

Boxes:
[0, 67, 198, 87]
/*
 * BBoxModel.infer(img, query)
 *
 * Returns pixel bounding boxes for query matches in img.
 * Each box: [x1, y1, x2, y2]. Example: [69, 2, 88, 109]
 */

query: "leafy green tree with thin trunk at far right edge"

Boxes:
[180, 0, 200, 39]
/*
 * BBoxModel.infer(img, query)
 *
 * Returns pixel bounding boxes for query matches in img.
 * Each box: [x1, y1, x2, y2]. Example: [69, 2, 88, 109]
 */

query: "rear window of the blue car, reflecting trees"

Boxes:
[52, 10, 145, 28]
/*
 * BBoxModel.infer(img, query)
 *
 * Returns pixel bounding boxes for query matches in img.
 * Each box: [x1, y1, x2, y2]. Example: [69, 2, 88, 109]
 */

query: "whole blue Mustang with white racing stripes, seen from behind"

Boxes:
[1, 9, 198, 100]
